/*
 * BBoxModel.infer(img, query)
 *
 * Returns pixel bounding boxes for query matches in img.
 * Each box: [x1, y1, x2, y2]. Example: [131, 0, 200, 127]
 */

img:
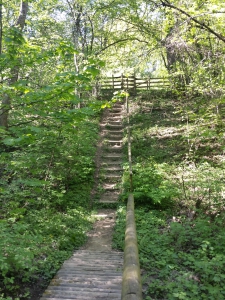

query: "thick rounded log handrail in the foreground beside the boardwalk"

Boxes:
[121, 194, 142, 300]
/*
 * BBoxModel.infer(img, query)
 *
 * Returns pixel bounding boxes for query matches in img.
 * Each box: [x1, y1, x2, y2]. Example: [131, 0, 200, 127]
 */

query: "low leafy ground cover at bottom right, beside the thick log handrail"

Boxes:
[114, 207, 225, 300]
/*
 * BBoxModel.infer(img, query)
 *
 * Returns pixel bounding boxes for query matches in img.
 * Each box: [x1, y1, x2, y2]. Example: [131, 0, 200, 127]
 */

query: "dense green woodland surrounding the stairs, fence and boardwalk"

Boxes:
[0, 0, 225, 300]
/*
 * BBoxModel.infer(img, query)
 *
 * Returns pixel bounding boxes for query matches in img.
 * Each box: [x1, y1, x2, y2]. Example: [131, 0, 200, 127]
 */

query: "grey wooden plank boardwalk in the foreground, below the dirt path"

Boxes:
[41, 250, 123, 300]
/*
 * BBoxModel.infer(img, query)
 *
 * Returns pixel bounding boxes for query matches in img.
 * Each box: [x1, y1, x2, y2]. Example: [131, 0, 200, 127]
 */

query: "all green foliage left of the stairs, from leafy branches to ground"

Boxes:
[0, 13, 104, 299]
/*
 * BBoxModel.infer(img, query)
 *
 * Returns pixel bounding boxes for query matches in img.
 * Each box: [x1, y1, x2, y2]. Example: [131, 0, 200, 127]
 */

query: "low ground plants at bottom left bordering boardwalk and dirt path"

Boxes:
[0, 207, 91, 297]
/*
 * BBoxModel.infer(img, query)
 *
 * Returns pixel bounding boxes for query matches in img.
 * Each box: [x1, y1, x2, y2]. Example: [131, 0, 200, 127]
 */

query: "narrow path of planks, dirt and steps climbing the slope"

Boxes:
[41, 104, 123, 300]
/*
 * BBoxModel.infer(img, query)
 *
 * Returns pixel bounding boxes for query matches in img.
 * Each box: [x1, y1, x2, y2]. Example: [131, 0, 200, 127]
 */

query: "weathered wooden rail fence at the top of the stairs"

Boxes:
[98, 74, 170, 94]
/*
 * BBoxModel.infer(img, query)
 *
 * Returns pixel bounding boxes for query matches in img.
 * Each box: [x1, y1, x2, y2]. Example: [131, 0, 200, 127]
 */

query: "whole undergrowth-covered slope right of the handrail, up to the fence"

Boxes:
[113, 93, 225, 300]
